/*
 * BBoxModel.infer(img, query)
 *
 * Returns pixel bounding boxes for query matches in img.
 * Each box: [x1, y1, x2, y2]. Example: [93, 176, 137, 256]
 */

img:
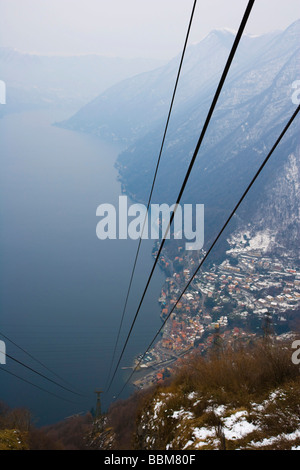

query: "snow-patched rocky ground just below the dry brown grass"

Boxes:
[136, 380, 300, 450]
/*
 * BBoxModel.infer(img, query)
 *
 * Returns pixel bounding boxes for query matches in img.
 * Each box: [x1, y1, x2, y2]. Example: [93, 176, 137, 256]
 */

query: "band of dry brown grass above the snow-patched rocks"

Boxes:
[170, 341, 300, 406]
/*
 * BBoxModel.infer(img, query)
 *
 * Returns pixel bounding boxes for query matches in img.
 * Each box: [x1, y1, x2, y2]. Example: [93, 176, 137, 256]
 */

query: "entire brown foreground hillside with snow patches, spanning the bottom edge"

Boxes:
[0, 333, 300, 451]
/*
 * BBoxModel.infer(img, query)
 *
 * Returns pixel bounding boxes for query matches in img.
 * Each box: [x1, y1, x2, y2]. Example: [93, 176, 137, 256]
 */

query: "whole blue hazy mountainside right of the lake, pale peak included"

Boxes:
[57, 21, 300, 253]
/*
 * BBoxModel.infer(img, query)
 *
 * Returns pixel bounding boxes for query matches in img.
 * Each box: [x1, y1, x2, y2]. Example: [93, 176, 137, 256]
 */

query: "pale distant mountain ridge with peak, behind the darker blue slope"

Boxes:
[56, 30, 282, 142]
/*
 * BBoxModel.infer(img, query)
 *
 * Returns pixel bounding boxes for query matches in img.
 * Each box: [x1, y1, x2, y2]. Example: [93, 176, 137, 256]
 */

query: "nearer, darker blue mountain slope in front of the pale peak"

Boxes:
[113, 22, 300, 203]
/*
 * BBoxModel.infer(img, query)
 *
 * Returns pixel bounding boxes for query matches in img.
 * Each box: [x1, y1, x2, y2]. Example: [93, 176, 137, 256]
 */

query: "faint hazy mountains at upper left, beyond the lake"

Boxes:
[0, 47, 161, 112]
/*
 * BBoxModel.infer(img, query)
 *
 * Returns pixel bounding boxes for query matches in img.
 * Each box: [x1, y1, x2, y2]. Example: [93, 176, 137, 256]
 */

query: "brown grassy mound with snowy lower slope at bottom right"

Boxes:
[99, 342, 300, 451]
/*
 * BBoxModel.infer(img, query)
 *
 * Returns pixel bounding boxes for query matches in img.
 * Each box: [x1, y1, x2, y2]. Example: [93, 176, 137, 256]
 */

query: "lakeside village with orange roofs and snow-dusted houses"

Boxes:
[134, 242, 300, 388]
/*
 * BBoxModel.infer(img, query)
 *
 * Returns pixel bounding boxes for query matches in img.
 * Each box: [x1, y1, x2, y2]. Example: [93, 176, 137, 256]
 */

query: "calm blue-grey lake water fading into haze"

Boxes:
[0, 111, 164, 424]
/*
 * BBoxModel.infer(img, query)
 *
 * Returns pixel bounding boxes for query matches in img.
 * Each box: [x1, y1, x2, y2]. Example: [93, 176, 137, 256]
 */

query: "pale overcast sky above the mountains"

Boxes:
[0, 0, 300, 59]
